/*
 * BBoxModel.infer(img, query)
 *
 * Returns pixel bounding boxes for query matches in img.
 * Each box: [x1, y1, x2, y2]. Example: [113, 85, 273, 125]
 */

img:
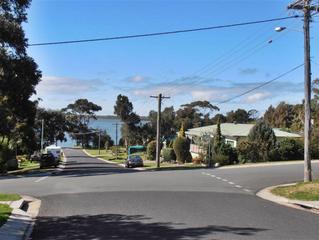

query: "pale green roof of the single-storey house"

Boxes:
[186, 123, 301, 138]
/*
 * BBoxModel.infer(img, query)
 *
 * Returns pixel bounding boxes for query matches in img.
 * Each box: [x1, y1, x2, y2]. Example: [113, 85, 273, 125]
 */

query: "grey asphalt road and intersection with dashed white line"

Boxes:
[0, 149, 319, 240]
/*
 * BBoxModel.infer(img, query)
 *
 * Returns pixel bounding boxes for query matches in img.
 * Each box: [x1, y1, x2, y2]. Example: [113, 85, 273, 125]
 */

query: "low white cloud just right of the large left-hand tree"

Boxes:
[36, 76, 103, 96]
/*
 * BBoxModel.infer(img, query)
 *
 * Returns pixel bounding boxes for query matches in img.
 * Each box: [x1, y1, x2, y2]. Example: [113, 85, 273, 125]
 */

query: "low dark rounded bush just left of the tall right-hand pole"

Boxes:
[278, 139, 303, 160]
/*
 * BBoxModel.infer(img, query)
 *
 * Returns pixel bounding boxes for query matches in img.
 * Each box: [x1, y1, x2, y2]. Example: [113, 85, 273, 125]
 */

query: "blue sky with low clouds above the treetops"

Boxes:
[24, 0, 319, 115]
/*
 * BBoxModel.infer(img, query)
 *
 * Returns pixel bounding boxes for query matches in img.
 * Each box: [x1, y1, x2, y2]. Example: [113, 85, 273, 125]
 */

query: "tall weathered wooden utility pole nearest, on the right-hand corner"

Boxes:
[288, 0, 318, 182]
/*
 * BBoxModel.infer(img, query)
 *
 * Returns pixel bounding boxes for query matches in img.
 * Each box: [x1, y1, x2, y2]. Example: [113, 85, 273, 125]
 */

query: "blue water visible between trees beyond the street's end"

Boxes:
[58, 118, 122, 147]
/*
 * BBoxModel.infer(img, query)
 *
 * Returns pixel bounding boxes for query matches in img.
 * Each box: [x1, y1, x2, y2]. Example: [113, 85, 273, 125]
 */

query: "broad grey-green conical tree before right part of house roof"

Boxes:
[248, 121, 276, 161]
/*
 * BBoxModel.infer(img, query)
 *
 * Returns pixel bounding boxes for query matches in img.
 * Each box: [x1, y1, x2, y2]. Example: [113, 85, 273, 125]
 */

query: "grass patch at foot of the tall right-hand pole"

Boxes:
[272, 179, 319, 201]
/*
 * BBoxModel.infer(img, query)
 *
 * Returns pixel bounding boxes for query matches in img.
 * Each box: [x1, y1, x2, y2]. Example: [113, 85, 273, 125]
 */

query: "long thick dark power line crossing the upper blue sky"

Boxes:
[28, 15, 301, 47]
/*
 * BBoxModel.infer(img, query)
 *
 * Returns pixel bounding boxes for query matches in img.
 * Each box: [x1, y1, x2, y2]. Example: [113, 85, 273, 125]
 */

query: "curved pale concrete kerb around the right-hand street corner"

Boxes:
[256, 183, 319, 214]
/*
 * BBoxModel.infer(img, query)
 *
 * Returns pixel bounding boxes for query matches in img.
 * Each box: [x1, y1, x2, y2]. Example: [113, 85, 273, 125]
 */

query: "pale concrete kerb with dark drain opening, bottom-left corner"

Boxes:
[0, 196, 41, 240]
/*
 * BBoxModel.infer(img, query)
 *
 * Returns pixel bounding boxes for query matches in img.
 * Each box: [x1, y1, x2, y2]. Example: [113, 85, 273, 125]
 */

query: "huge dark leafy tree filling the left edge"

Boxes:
[0, 0, 41, 163]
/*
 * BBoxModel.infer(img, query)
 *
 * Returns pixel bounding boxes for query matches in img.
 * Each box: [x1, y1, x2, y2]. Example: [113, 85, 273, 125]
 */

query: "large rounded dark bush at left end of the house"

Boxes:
[173, 137, 192, 163]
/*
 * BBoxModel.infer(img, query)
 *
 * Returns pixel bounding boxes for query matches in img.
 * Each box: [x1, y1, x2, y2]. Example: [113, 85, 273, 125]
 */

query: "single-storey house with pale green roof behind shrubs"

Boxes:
[185, 123, 301, 156]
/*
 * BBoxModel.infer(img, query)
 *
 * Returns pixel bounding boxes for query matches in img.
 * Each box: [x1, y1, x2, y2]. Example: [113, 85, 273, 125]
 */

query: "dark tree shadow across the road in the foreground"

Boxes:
[32, 214, 267, 240]
